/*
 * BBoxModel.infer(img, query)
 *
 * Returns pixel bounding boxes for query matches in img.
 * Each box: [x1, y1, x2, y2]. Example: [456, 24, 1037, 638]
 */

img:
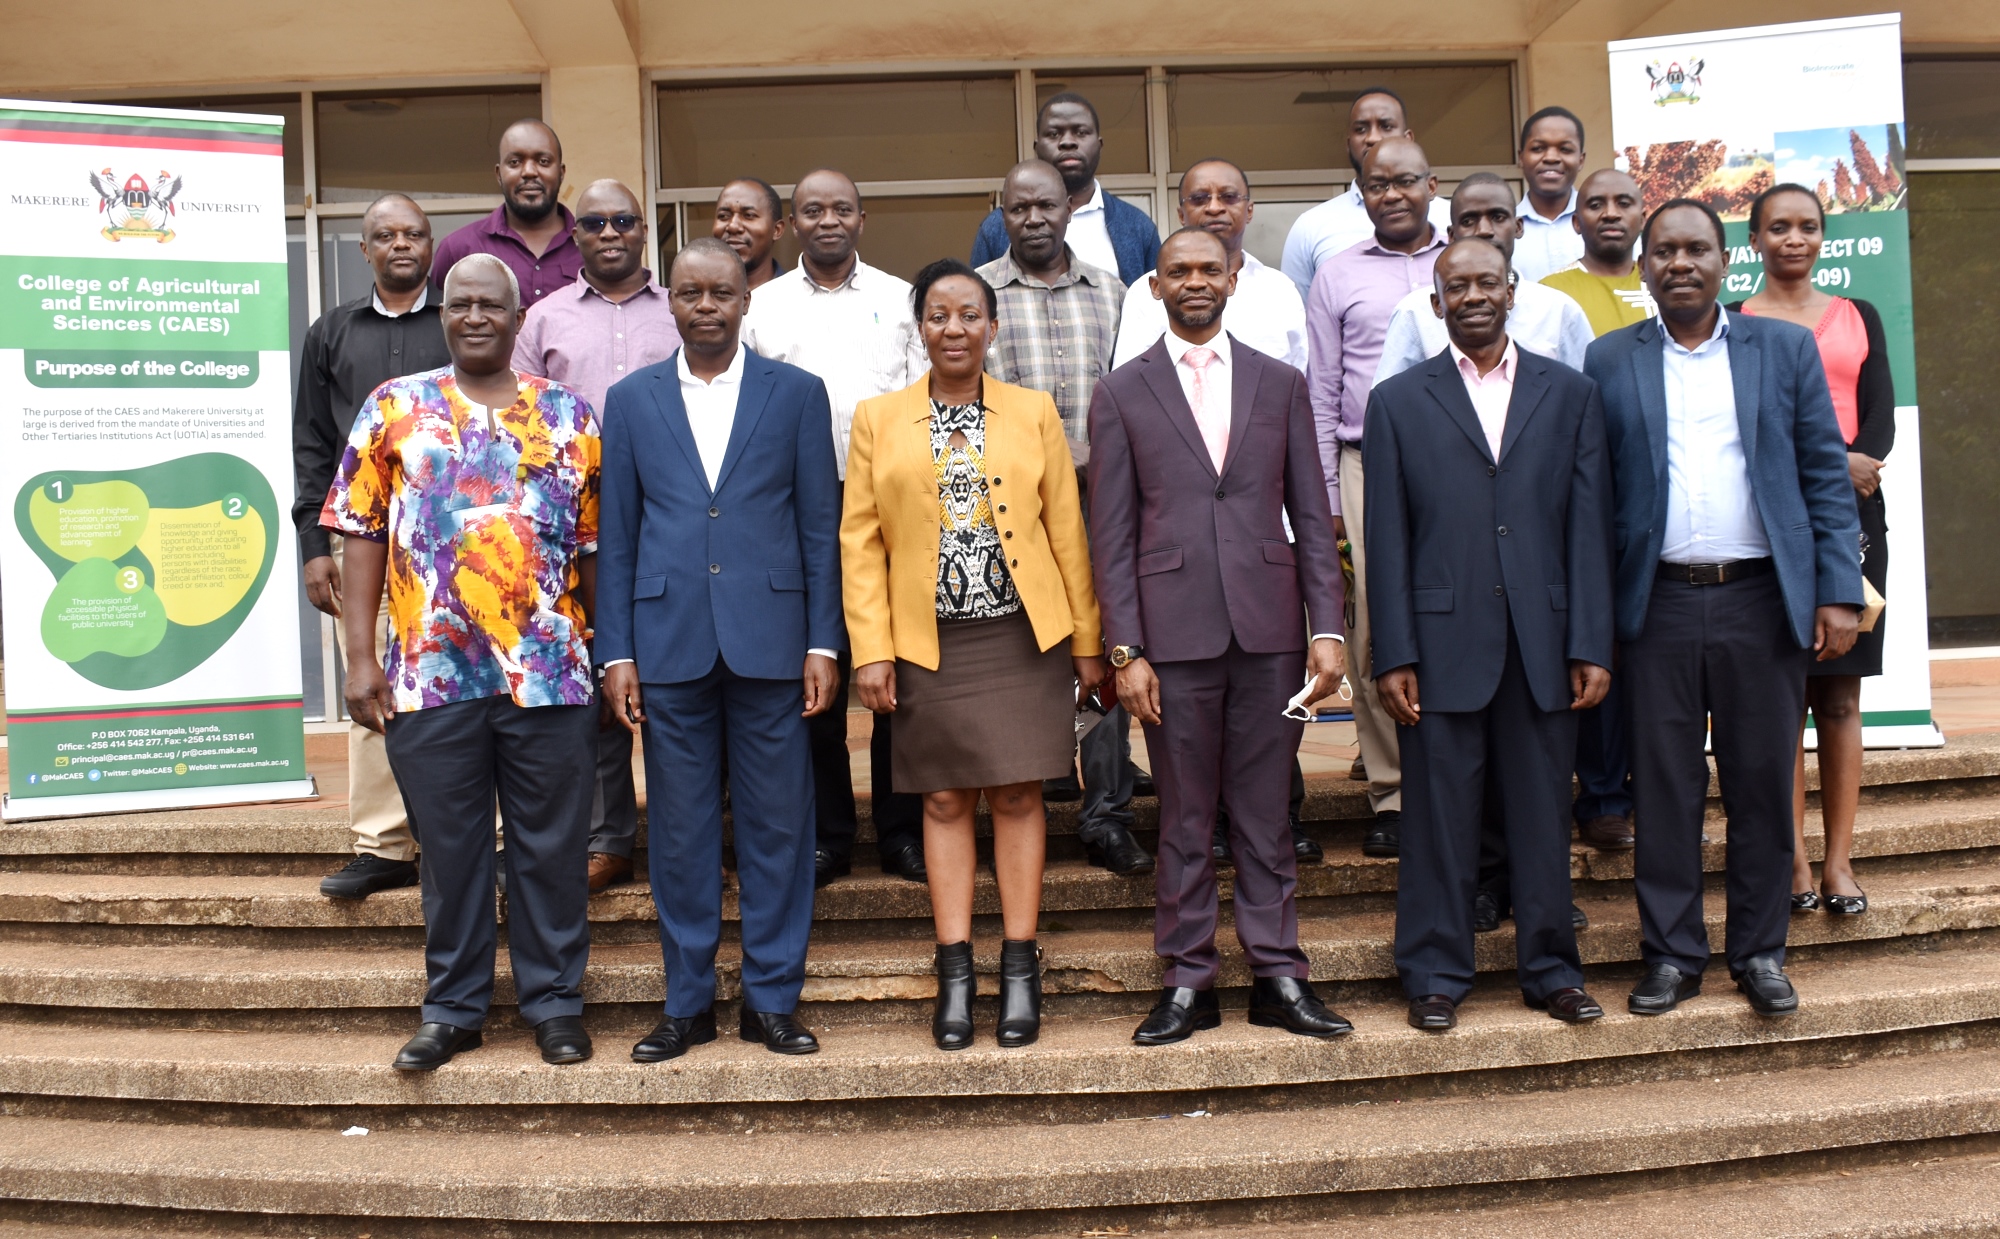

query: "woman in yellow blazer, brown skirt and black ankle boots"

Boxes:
[840, 258, 1106, 1049]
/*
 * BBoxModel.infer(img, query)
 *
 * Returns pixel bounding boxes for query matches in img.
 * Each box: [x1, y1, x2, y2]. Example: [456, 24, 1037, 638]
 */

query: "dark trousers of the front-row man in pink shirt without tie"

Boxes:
[1396, 629, 1584, 1001]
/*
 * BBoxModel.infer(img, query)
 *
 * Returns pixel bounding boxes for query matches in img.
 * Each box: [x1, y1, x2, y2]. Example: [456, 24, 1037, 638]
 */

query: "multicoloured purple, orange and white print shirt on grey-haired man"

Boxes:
[320, 366, 600, 709]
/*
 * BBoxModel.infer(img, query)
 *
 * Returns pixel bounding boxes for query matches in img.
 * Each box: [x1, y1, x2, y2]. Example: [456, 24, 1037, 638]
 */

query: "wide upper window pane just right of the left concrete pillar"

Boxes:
[660, 78, 1014, 190]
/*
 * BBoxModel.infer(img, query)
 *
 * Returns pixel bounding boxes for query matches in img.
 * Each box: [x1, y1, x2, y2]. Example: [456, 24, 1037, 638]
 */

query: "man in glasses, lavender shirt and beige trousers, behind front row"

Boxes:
[1306, 138, 1446, 855]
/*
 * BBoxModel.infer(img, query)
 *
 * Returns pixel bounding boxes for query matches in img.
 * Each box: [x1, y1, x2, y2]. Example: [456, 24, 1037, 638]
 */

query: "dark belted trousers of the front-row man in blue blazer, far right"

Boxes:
[1618, 574, 1812, 975]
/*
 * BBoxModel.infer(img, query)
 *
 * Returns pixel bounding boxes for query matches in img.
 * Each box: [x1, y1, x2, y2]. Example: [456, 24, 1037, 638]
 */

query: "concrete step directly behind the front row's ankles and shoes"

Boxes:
[0, 853, 2000, 1011]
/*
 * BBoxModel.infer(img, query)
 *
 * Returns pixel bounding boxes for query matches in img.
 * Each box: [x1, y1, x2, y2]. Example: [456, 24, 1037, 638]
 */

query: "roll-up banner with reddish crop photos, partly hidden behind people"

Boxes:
[1610, 14, 1944, 747]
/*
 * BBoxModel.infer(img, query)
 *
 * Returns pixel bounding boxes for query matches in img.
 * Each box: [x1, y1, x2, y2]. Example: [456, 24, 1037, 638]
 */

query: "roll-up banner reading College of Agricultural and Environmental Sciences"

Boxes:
[0, 100, 314, 819]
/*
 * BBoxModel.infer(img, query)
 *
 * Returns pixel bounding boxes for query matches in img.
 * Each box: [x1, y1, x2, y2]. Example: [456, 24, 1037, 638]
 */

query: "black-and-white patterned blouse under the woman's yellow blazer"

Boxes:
[930, 400, 1020, 620]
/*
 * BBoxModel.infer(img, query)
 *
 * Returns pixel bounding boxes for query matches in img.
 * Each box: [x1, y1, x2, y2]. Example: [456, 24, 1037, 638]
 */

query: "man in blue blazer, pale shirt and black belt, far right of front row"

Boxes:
[1584, 198, 1862, 1015]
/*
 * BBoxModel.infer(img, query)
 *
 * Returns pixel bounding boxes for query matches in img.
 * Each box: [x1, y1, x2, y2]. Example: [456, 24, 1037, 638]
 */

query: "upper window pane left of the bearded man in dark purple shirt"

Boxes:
[312, 88, 542, 202]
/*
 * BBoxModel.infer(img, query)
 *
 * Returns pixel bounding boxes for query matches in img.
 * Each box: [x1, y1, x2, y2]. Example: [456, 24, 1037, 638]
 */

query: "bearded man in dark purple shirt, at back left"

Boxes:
[430, 120, 584, 310]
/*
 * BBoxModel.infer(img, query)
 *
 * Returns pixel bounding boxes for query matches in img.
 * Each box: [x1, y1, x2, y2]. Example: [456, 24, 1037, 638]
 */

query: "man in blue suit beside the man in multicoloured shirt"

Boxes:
[596, 238, 846, 1063]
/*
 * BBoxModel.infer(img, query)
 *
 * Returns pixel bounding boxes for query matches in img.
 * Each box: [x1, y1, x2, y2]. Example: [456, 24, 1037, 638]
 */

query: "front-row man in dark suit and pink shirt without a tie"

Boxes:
[1362, 238, 1612, 1031]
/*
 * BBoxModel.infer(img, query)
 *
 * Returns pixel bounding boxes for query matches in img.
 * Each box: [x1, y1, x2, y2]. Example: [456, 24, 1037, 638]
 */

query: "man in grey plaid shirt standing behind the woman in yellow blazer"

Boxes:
[978, 160, 1152, 873]
